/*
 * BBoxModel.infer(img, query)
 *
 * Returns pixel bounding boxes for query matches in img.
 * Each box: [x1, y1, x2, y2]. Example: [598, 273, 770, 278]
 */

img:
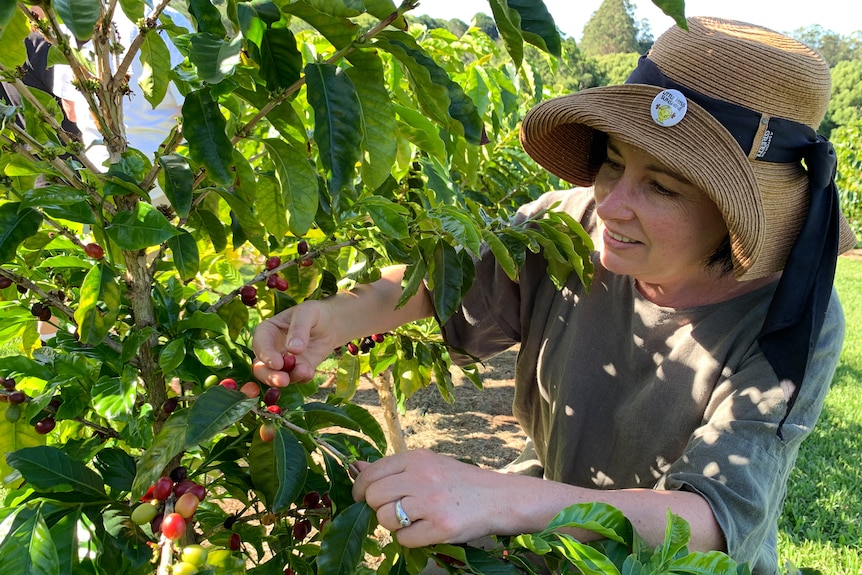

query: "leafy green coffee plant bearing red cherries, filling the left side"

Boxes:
[0, 0, 760, 575]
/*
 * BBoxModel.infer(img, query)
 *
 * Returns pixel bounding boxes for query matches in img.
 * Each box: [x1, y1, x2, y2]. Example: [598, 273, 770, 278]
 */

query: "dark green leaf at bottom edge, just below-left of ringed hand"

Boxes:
[317, 501, 374, 575]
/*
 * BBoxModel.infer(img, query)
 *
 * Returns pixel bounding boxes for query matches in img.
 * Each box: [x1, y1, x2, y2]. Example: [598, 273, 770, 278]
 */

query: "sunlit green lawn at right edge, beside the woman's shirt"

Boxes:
[778, 258, 862, 574]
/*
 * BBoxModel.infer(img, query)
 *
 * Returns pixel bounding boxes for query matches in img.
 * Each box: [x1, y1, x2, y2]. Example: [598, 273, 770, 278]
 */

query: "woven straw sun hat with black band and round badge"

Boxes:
[521, 17, 855, 280]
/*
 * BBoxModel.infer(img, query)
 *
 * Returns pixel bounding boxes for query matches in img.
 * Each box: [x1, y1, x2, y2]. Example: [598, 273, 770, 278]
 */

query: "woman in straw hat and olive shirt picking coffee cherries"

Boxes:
[254, 18, 855, 574]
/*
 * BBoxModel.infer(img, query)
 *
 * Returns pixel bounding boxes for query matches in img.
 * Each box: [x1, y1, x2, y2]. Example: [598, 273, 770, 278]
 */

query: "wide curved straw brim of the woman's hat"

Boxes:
[520, 84, 767, 279]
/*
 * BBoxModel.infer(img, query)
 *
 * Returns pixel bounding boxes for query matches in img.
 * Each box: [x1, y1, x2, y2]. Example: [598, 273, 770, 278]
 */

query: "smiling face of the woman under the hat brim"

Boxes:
[595, 137, 727, 291]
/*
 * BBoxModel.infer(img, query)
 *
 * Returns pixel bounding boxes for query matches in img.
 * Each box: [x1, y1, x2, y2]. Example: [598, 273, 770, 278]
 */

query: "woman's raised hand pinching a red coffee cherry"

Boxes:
[252, 300, 342, 387]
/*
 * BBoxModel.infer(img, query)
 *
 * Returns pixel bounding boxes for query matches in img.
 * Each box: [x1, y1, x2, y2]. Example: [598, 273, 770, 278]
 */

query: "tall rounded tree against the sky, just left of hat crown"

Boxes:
[580, 0, 642, 56]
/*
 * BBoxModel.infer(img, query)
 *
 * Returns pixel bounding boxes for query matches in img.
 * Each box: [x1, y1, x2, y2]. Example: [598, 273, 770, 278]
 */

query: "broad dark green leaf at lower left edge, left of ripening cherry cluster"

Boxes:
[6, 445, 105, 497]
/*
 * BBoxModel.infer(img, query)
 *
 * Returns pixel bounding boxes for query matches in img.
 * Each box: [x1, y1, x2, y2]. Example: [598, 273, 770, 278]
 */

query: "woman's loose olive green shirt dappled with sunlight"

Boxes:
[443, 190, 844, 575]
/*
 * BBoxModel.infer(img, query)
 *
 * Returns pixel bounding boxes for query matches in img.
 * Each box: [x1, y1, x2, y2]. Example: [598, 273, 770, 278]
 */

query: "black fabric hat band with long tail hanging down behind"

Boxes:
[626, 56, 840, 439]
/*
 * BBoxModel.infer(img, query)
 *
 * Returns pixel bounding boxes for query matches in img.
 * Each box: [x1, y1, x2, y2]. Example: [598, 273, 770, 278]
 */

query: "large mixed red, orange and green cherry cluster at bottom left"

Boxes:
[132, 466, 207, 541]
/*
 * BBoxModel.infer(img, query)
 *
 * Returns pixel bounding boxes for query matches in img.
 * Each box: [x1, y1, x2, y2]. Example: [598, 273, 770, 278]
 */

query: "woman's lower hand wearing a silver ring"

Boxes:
[353, 450, 508, 547]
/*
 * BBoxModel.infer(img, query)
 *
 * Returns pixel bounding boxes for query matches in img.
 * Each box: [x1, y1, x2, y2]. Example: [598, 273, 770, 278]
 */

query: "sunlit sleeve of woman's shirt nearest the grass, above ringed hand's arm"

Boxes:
[656, 291, 844, 574]
